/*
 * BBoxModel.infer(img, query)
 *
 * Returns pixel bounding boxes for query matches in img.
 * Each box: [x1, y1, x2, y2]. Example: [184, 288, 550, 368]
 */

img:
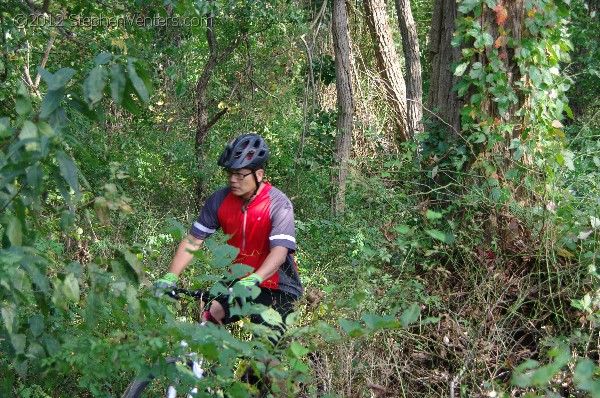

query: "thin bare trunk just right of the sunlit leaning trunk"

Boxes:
[396, 0, 423, 134]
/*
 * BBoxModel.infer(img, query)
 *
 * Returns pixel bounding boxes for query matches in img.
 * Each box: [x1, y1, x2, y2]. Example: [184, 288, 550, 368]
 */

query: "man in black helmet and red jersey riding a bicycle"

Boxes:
[154, 134, 302, 332]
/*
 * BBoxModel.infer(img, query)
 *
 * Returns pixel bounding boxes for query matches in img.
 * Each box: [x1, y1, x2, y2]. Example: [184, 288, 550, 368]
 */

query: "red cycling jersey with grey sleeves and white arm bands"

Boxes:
[190, 182, 302, 297]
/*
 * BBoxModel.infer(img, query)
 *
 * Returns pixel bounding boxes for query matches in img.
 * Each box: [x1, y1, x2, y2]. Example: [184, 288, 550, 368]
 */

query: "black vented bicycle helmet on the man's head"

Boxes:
[217, 134, 269, 170]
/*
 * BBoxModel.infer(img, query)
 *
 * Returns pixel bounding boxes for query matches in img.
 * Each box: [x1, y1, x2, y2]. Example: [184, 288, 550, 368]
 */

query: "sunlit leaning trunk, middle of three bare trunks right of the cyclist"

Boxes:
[364, 0, 412, 142]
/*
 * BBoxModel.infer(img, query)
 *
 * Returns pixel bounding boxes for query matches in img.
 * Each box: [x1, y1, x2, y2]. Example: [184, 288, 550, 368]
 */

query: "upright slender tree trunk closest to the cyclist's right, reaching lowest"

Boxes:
[332, 0, 354, 213]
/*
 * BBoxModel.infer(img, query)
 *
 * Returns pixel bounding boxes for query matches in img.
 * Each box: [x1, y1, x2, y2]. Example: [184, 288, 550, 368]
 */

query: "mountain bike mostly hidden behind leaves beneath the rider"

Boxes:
[122, 288, 209, 398]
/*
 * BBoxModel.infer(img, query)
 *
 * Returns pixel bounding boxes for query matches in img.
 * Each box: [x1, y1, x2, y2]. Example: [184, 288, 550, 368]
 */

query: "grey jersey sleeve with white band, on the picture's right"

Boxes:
[269, 189, 296, 252]
